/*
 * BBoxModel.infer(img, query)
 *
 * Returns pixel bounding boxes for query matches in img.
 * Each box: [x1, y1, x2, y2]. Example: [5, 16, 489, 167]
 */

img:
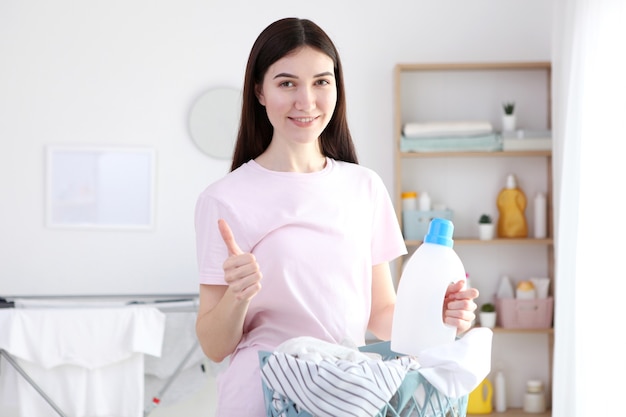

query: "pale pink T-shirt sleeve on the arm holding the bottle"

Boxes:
[372, 175, 407, 265]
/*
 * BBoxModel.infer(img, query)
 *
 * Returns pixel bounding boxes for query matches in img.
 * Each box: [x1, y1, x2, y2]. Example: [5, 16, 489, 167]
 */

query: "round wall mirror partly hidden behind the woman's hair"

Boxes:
[189, 88, 241, 159]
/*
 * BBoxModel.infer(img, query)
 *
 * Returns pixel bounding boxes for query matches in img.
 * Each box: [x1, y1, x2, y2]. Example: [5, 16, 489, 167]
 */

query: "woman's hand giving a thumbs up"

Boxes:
[217, 219, 263, 301]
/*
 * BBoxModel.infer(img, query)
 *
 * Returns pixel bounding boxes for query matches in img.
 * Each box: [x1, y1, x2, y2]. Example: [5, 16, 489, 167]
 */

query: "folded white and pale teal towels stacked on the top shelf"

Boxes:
[400, 121, 502, 152]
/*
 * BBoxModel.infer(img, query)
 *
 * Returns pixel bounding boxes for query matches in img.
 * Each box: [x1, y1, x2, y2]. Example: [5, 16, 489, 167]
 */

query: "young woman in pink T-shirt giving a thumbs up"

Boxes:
[196, 18, 478, 417]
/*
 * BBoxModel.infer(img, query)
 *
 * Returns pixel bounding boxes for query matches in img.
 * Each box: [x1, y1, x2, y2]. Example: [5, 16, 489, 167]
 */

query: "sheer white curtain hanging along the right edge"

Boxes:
[552, 0, 626, 417]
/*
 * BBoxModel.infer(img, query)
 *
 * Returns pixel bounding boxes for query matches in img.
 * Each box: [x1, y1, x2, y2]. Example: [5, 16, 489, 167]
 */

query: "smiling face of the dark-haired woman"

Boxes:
[257, 47, 337, 147]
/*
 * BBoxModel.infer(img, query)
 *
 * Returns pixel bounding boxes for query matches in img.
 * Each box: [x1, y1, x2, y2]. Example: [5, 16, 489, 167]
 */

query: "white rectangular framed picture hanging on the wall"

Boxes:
[46, 146, 156, 230]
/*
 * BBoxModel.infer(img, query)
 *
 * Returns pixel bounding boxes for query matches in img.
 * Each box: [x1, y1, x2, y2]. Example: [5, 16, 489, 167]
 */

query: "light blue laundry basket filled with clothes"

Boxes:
[259, 342, 467, 417]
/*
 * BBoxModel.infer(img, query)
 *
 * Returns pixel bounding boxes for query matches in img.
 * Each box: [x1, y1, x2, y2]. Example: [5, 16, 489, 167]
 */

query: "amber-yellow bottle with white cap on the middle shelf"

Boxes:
[497, 174, 528, 237]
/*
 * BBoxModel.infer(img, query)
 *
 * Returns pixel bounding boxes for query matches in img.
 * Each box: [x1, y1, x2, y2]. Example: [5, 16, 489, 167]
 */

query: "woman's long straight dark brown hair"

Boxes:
[231, 18, 358, 171]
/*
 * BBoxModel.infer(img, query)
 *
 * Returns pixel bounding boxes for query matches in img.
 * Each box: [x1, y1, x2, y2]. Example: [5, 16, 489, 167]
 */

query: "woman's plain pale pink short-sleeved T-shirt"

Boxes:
[195, 158, 406, 417]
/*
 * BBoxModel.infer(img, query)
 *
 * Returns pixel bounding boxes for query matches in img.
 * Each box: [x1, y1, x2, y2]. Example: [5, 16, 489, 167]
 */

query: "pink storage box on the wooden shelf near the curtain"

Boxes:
[496, 297, 554, 329]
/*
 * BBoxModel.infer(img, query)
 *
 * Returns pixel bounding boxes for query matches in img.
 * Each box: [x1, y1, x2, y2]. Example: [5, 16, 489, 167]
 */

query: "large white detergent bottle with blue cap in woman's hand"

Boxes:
[391, 218, 465, 356]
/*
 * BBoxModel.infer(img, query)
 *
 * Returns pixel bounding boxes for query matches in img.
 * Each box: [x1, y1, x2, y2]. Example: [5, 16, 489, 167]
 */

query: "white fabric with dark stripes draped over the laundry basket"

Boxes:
[261, 352, 419, 417]
